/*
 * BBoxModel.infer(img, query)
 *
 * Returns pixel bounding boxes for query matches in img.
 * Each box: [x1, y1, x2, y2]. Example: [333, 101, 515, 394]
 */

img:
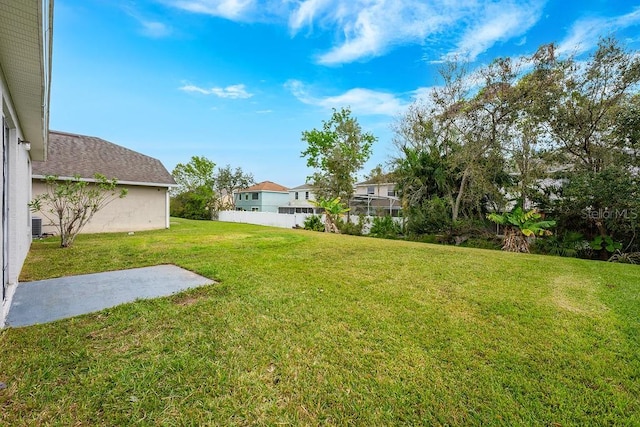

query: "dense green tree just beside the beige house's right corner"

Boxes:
[171, 156, 219, 219]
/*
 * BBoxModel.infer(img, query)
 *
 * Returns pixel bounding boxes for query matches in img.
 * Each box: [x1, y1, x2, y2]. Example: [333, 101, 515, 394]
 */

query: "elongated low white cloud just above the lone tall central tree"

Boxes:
[285, 80, 407, 116]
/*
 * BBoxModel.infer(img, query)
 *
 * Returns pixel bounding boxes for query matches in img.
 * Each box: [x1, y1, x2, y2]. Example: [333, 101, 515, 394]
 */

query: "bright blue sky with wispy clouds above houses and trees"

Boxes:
[50, 0, 640, 187]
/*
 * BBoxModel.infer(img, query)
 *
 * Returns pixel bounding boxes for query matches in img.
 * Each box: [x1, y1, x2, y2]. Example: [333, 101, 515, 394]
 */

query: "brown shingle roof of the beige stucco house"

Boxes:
[32, 131, 176, 186]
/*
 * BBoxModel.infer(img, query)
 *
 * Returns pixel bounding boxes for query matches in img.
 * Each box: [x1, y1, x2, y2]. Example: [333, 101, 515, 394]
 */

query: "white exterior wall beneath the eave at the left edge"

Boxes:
[0, 73, 31, 327]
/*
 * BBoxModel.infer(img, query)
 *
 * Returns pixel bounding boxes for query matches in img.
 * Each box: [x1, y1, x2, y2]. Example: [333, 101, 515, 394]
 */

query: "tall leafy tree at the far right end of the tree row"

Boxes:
[528, 38, 640, 251]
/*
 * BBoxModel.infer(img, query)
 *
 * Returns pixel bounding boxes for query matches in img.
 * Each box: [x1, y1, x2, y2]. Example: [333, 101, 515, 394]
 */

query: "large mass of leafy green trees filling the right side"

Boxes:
[393, 38, 640, 259]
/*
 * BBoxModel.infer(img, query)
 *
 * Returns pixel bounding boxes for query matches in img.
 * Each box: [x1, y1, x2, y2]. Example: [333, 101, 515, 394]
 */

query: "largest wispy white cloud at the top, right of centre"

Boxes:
[289, 0, 545, 65]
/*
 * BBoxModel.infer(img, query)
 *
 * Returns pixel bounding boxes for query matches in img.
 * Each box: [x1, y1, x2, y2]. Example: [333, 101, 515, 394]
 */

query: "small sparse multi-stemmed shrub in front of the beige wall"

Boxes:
[29, 174, 127, 248]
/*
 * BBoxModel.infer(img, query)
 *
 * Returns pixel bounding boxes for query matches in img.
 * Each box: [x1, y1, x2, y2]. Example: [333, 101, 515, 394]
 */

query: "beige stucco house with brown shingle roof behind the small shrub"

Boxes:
[32, 133, 176, 233]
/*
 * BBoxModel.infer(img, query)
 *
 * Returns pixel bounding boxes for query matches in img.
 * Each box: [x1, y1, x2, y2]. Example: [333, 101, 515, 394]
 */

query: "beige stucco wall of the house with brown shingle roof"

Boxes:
[32, 179, 169, 234]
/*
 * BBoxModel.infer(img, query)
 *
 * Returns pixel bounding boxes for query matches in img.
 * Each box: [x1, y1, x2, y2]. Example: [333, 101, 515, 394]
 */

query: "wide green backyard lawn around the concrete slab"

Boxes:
[0, 220, 640, 426]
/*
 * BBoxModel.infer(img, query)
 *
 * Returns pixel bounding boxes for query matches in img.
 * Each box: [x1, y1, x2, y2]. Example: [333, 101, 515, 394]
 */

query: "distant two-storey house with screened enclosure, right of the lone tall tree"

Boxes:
[349, 180, 402, 216]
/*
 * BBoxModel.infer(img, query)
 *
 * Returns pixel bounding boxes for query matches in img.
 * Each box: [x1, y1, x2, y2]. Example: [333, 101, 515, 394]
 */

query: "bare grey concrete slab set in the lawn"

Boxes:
[6, 265, 213, 327]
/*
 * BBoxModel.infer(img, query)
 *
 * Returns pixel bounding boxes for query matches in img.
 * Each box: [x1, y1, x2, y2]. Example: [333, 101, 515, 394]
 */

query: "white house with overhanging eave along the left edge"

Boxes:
[0, 0, 53, 327]
